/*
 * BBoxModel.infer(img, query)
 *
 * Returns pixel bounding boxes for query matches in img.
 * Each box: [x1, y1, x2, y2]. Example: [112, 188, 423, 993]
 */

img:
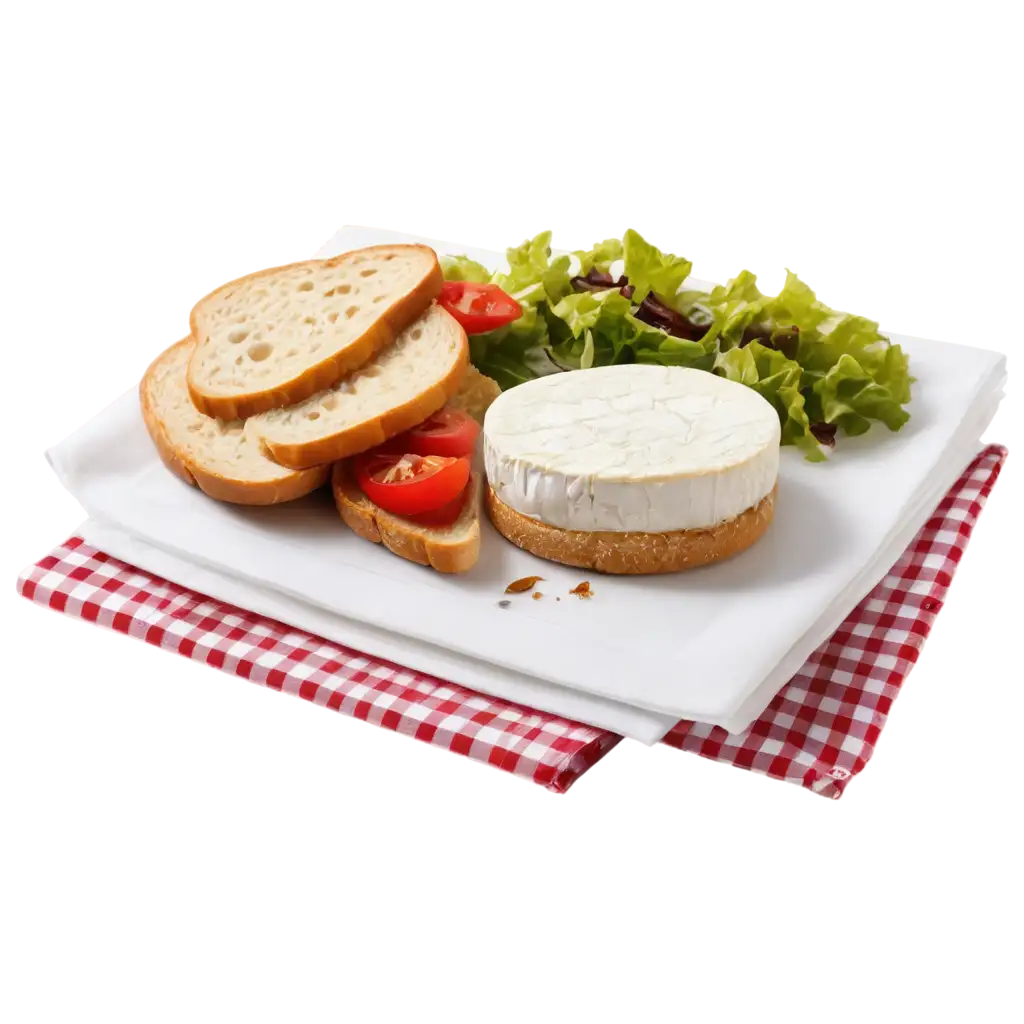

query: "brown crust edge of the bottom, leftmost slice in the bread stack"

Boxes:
[138, 338, 331, 505]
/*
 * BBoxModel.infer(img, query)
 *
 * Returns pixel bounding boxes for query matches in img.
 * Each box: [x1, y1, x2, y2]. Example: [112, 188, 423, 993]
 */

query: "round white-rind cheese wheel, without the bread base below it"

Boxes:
[483, 364, 780, 534]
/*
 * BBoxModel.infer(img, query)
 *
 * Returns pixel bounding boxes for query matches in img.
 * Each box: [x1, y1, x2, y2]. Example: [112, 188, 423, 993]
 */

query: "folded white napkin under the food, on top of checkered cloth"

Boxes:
[41, 225, 1002, 744]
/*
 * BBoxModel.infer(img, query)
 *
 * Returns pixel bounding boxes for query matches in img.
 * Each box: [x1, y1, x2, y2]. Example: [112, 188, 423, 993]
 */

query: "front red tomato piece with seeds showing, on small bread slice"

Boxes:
[352, 451, 470, 516]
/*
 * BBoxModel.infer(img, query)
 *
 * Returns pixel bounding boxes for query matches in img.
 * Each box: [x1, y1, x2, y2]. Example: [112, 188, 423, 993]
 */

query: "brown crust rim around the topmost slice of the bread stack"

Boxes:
[187, 245, 444, 419]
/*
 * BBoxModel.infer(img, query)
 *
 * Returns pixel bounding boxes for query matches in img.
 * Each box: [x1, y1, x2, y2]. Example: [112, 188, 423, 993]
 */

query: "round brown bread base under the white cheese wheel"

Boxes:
[484, 484, 778, 575]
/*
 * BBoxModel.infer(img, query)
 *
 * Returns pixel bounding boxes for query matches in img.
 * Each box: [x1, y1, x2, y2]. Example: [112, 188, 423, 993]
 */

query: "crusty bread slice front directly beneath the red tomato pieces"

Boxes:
[331, 462, 483, 573]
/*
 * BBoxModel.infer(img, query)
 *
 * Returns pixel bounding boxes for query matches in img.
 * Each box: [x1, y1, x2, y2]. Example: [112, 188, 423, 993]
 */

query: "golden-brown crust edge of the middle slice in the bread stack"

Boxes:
[253, 316, 468, 469]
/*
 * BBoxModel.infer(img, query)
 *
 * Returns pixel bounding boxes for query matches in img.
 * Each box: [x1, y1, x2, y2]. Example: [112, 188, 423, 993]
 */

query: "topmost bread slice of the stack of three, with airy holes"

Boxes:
[188, 245, 443, 420]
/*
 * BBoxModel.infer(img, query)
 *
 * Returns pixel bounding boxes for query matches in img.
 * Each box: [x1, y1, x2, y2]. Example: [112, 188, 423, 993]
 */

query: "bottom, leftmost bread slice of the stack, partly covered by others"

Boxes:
[139, 338, 329, 505]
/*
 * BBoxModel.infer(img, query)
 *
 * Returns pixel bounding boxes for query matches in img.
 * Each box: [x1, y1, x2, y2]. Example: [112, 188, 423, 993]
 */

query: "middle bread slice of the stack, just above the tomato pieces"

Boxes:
[246, 305, 469, 469]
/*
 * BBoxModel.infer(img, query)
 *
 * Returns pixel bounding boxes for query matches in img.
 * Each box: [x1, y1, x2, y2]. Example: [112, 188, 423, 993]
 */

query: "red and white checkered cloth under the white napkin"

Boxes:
[19, 445, 1007, 796]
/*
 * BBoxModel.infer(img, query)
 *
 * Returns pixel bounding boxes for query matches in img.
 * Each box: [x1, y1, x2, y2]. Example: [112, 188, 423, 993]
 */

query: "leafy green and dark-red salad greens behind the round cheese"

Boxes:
[441, 229, 914, 461]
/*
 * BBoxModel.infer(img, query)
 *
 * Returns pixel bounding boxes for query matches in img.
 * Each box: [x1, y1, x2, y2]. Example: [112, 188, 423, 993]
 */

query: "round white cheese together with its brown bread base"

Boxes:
[483, 364, 780, 573]
